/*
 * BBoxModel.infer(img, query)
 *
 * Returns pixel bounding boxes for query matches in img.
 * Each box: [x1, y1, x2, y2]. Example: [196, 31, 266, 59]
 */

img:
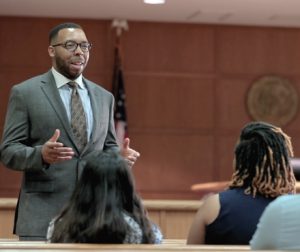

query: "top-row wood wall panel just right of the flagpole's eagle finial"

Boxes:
[124, 22, 215, 74]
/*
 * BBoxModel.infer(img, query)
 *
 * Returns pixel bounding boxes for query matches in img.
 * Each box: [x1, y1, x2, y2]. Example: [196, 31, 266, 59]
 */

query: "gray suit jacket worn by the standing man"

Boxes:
[0, 71, 118, 236]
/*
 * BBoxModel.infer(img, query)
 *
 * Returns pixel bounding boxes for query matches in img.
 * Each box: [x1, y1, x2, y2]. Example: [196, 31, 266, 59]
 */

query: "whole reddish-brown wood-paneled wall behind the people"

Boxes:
[0, 17, 300, 199]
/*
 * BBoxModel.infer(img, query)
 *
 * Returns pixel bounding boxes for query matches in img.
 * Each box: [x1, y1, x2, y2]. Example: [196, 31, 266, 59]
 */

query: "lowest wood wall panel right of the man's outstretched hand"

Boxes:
[133, 133, 214, 199]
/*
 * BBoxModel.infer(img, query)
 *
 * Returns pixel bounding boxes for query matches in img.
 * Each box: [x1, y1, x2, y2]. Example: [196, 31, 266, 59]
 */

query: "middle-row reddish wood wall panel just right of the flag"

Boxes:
[125, 73, 215, 132]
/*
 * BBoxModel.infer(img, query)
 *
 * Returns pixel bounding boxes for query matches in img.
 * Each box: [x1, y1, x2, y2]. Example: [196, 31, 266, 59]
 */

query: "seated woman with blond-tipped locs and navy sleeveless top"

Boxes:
[187, 122, 295, 245]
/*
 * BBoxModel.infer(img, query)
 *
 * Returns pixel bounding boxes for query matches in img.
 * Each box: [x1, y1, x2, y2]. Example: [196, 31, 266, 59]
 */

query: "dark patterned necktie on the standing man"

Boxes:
[68, 82, 87, 152]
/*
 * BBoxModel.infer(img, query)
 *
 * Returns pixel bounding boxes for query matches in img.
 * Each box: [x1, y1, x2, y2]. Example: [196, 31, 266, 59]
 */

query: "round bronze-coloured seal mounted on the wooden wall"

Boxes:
[247, 75, 298, 127]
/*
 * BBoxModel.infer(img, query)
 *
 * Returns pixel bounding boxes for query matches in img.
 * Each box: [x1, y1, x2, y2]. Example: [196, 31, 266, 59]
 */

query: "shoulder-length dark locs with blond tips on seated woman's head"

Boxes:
[229, 122, 296, 197]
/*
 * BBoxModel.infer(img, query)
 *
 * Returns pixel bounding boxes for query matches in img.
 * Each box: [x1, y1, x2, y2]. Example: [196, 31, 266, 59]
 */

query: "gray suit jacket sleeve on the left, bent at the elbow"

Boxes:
[0, 86, 46, 171]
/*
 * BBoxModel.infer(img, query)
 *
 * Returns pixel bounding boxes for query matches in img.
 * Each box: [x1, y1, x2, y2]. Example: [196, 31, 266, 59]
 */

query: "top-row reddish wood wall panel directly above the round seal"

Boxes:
[216, 27, 300, 75]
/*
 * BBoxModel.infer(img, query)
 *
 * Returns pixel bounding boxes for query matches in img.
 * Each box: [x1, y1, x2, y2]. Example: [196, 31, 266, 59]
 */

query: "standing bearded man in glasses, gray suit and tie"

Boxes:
[0, 23, 139, 240]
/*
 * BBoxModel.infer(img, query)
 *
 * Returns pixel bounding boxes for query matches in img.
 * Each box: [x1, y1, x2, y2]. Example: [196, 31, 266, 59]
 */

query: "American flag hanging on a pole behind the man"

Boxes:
[112, 42, 128, 147]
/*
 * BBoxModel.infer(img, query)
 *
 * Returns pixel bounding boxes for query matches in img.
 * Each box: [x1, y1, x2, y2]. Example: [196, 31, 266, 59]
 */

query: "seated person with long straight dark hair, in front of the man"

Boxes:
[47, 152, 162, 243]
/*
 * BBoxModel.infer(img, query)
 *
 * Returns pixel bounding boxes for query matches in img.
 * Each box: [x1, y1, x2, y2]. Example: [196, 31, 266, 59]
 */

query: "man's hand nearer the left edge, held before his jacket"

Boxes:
[42, 129, 74, 164]
